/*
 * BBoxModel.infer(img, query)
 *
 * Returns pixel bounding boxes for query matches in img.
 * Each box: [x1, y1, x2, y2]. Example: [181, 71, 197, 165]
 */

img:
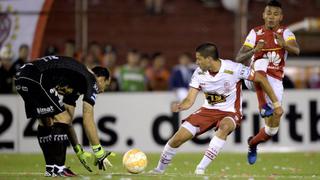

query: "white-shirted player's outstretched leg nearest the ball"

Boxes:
[154, 122, 192, 173]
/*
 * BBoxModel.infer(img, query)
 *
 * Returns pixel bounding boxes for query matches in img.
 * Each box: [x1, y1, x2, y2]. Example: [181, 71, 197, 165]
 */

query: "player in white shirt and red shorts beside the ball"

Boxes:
[153, 43, 283, 174]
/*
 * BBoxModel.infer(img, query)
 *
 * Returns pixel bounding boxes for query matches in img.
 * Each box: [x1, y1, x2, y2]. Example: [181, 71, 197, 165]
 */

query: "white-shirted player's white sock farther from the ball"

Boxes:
[197, 136, 226, 169]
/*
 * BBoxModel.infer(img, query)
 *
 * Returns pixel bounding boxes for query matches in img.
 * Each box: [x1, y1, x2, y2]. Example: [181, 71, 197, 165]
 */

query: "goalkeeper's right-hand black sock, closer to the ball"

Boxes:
[51, 123, 69, 166]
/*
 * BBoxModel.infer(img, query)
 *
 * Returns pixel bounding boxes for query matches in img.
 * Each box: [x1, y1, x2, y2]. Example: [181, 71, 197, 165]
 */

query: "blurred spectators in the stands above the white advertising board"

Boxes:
[0, 40, 320, 94]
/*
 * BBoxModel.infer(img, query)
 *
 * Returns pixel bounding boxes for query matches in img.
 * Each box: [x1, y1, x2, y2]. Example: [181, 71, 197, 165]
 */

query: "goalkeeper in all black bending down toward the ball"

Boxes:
[15, 56, 111, 176]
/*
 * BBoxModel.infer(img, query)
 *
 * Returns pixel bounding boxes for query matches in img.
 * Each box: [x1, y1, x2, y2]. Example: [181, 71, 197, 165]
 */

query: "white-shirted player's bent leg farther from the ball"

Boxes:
[195, 117, 236, 175]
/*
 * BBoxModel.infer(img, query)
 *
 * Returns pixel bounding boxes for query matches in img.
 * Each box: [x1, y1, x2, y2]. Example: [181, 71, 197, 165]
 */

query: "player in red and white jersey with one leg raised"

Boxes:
[236, 0, 300, 164]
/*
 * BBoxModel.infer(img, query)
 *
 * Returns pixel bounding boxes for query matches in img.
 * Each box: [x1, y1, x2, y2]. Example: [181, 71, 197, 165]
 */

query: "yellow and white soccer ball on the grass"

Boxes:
[122, 149, 148, 174]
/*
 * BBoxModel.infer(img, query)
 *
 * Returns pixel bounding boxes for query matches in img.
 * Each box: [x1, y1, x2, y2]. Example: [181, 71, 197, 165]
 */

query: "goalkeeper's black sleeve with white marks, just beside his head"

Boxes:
[83, 75, 98, 106]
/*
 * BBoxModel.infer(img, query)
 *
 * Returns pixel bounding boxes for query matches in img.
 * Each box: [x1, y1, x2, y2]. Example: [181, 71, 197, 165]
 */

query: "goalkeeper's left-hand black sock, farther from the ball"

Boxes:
[37, 125, 55, 165]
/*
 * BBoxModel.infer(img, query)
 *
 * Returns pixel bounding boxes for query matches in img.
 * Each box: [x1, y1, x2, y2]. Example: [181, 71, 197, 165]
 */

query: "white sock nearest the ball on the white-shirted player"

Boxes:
[156, 143, 178, 172]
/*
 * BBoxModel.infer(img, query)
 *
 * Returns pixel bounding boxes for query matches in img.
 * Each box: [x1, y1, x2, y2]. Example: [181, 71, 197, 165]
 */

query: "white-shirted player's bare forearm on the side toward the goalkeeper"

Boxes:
[171, 87, 199, 112]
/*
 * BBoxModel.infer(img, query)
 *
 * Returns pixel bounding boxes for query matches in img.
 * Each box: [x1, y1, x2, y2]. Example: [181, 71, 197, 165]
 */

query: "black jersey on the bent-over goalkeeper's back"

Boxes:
[32, 56, 98, 105]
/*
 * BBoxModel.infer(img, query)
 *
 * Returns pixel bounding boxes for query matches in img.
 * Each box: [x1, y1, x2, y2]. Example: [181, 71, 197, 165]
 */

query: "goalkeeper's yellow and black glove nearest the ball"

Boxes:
[91, 144, 115, 171]
